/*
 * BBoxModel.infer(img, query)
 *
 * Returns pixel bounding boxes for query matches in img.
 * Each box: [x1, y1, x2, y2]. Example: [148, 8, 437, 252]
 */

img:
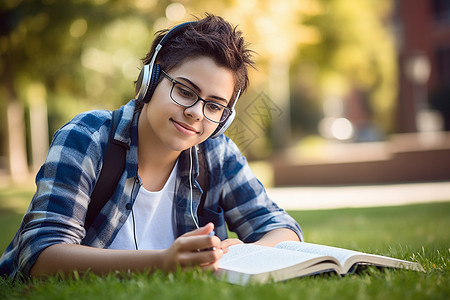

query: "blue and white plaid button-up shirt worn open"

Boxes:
[0, 100, 302, 277]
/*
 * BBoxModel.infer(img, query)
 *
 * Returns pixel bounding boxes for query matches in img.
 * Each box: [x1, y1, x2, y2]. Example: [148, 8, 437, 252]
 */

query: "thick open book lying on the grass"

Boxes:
[217, 242, 424, 285]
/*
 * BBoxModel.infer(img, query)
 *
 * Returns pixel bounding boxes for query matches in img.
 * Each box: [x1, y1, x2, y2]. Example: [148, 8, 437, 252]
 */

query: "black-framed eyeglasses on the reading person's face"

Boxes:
[161, 70, 231, 123]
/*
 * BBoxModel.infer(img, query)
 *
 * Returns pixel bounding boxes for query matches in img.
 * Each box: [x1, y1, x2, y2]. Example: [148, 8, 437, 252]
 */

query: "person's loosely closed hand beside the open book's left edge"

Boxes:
[162, 223, 223, 272]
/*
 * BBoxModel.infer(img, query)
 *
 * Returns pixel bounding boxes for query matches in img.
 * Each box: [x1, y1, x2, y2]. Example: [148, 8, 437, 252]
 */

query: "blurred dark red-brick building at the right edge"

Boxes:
[394, 0, 450, 132]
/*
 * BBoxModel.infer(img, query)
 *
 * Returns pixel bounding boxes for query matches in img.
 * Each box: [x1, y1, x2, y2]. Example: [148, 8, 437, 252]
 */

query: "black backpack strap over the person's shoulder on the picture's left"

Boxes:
[85, 109, 129, 231]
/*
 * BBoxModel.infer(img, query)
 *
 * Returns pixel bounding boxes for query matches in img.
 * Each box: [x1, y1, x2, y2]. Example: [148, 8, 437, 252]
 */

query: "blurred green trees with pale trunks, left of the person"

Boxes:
[0, 0, 168, 181]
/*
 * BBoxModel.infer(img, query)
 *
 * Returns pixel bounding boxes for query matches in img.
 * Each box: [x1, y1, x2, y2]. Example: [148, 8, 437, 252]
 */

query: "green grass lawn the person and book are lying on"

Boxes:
[0, 189, 450, 300]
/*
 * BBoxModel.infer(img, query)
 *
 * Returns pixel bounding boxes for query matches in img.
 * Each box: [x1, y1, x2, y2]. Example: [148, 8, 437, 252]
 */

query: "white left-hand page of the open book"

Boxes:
[219, 244, 335, 274]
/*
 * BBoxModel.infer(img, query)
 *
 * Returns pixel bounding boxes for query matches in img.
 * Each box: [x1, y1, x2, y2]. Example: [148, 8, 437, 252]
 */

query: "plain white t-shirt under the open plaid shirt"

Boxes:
[109, 162, 178, 250]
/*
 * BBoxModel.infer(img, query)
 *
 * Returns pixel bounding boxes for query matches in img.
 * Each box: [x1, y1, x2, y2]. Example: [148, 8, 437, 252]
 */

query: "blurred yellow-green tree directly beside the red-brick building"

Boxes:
[292, 0, 397, 138]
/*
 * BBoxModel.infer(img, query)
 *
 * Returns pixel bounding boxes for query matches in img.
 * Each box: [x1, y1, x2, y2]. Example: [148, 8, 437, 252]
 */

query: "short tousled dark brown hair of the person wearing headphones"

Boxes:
[142, 14, 254, 106]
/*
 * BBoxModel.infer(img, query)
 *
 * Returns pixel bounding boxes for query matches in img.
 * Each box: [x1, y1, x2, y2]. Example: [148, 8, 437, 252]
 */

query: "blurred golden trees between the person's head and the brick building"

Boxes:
[183, 0, 397, 150]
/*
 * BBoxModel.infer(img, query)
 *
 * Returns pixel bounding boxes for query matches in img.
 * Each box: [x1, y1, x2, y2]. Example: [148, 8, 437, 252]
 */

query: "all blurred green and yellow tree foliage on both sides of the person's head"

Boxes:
[0, 0, 396, 176]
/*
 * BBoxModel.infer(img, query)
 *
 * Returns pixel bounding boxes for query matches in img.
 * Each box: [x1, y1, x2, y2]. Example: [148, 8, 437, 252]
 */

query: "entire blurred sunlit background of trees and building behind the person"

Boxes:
[0, 0, 450, 186]
